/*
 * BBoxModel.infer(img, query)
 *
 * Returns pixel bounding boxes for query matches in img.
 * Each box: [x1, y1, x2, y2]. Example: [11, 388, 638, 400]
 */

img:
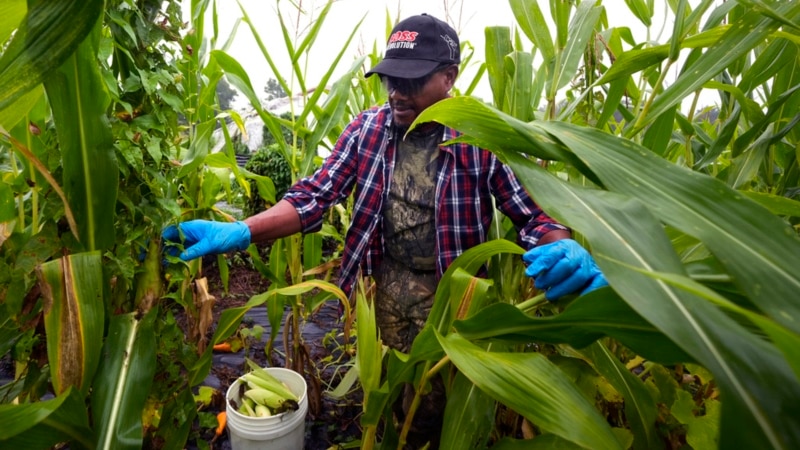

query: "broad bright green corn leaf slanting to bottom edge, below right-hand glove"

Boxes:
[439, 334, 622, 449]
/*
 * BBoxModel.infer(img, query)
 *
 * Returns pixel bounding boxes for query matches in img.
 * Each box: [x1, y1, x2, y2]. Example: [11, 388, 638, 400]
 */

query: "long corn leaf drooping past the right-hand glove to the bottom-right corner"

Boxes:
[512, 151, 800, 448]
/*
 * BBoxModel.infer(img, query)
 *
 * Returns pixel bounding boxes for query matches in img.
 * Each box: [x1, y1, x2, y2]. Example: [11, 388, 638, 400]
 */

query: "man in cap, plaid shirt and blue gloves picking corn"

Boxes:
[164, 14, 606, 448]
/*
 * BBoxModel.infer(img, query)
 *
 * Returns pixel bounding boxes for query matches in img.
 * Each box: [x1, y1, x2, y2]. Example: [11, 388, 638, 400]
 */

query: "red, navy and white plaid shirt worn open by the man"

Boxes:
[284, 104, 566, 295]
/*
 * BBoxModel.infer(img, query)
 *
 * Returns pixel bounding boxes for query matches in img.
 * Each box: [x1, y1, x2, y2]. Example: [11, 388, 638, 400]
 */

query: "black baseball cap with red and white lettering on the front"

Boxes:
[366, 14, 461, 78]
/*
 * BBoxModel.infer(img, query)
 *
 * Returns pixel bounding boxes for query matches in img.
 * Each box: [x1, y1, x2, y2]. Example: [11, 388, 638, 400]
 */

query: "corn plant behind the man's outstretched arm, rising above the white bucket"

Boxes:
[208, 2, 363, 384]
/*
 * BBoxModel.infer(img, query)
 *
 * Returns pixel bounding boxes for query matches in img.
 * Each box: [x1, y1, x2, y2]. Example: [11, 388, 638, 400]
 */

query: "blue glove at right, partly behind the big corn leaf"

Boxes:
[522, 239, 608, 301]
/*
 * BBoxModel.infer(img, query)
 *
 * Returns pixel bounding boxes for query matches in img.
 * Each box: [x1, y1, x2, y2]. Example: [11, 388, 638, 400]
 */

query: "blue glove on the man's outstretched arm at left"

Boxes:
[161, 220, 250, 261]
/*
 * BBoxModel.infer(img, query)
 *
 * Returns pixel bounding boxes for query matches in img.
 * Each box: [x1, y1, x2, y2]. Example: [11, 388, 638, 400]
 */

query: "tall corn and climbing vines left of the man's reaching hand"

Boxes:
[0, 0, 256, 448]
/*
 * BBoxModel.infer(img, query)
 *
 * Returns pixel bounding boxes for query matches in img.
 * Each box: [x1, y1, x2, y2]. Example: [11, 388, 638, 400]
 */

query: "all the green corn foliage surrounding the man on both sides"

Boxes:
[0, 0, 800, 449]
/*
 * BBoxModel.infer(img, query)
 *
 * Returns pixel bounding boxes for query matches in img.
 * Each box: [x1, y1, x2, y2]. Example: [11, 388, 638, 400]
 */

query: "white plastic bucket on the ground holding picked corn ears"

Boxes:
[225, 367, 308, 450]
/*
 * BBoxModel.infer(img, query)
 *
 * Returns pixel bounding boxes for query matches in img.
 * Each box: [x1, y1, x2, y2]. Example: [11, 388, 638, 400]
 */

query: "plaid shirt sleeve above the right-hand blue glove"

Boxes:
[492, 155, 569, 249]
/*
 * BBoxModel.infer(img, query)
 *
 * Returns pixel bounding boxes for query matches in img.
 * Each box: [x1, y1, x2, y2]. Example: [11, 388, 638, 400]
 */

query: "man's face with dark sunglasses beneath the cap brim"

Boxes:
[381, 65, 458, 128]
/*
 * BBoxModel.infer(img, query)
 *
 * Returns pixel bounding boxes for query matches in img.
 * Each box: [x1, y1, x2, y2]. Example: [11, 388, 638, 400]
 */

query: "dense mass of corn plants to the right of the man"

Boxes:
[354, 0, 800, 449]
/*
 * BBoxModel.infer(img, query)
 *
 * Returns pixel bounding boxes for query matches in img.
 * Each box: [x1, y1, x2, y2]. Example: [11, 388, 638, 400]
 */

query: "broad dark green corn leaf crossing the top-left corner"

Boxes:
[0, 0, 104, 111]
